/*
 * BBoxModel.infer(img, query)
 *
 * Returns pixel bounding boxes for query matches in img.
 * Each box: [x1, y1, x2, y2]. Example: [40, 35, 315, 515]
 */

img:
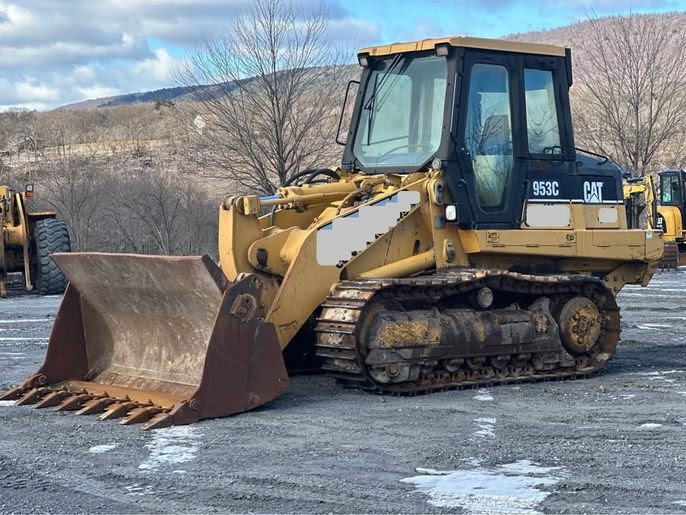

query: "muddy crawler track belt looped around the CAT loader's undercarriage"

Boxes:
[315, 269, 619, 395]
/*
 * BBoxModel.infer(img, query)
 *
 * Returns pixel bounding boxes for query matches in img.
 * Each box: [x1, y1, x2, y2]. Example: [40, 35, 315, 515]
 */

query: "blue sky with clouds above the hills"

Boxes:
[0, 0, 686, 110]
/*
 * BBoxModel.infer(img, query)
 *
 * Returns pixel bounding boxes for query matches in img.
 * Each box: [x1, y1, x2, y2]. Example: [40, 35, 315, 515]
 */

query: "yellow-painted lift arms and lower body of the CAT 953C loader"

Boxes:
[214, 171, 663, 347]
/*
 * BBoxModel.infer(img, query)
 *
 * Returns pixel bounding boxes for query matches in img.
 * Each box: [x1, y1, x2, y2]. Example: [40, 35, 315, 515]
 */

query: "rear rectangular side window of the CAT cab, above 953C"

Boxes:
[524, 68, 562, 154]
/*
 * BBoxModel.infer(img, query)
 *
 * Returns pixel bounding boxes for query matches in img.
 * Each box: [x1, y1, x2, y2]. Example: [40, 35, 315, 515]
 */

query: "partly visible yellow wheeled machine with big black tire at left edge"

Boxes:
[0, 184, 71, 297]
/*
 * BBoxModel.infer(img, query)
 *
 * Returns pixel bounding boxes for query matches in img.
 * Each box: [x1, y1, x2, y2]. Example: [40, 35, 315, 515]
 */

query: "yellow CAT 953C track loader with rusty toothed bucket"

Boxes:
[4, 37, 662, 428]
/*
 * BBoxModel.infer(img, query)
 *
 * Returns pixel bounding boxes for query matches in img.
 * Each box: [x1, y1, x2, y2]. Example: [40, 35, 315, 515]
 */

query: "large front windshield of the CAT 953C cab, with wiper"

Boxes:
[353, 54, 448, 167]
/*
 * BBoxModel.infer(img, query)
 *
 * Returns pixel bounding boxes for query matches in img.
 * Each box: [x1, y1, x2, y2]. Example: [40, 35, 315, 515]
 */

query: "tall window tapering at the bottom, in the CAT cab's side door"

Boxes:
[465, 63, 513, 211]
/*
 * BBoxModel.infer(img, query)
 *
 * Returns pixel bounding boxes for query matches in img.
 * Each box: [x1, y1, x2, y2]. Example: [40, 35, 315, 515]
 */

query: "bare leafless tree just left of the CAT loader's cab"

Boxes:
[179, 0, 344, 193]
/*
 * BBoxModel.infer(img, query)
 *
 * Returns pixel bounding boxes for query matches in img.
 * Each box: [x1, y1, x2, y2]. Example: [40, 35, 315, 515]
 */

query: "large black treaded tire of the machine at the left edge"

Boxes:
[33, 218, 71, 295]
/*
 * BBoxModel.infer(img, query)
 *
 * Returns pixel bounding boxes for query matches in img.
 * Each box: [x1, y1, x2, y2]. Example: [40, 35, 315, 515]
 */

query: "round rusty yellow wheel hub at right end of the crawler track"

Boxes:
[557, 296, 603, 356]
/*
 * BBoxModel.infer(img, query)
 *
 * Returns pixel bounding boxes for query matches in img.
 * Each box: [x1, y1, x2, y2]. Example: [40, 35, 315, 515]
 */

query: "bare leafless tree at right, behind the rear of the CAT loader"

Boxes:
[575, 14, 686, 175]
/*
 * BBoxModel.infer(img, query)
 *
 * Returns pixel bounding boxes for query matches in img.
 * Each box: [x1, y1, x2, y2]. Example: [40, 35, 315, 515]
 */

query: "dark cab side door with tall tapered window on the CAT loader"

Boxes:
[448, 50, 526, 229]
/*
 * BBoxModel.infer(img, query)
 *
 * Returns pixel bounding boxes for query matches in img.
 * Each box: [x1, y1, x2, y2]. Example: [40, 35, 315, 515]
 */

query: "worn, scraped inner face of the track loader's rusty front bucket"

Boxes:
[53, 253, 228, 395]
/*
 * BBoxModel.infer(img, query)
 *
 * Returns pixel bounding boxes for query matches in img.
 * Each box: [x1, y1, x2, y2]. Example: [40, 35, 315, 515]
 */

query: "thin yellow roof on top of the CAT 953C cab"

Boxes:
[358, 36, 565, 57]
